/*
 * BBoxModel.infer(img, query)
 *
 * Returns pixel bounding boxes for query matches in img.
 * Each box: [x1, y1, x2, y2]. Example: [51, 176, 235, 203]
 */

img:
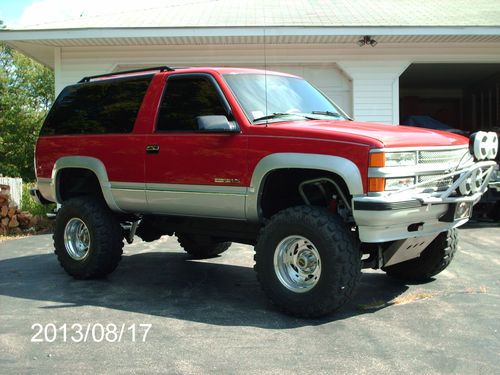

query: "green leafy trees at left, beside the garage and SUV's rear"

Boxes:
[0, 39, 54, 181]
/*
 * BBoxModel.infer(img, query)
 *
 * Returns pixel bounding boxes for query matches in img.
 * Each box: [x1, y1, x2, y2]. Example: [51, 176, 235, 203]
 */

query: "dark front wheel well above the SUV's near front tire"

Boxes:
[260, 168, 350, 219]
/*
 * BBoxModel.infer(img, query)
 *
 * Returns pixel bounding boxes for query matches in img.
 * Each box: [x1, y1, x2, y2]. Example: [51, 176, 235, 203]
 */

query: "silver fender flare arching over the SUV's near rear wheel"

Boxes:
[51, 156, 122, 212]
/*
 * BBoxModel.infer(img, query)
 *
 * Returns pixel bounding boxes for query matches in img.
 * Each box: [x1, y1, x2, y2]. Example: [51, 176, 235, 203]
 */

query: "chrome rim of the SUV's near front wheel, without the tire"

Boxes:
[274, 236, 321, 293]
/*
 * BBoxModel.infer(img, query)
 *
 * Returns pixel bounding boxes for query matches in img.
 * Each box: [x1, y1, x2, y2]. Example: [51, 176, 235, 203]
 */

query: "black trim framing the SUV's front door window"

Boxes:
[154, 73, 241, 134]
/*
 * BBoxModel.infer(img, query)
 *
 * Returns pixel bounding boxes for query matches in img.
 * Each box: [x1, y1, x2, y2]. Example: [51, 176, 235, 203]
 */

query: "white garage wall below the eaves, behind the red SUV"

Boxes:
[54, 43, 500, 124]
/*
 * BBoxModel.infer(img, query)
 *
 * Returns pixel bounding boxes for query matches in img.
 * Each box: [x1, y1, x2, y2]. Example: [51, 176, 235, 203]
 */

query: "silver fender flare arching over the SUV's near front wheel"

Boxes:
[245, 153, 364, 221]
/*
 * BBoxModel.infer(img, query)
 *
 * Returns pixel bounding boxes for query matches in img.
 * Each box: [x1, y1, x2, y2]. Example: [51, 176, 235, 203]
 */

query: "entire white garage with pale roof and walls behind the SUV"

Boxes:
[0, 0, 500, 128]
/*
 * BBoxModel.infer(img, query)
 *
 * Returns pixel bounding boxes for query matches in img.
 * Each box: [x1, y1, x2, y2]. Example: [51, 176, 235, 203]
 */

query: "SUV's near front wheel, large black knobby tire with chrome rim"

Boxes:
[255, 206, 361, 318]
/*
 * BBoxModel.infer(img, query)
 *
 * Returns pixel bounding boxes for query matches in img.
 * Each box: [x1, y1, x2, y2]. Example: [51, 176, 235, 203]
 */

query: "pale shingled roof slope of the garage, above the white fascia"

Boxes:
[8, 0, 500, 30]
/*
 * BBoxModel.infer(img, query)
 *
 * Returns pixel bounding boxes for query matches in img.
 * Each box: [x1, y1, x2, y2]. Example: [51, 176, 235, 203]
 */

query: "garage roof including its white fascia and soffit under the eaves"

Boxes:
[0, 0, 500, 67]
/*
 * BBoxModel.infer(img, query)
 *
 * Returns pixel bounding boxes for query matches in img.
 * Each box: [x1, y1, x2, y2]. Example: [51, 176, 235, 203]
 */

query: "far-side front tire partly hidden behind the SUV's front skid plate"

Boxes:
[382, 229, 458, 282]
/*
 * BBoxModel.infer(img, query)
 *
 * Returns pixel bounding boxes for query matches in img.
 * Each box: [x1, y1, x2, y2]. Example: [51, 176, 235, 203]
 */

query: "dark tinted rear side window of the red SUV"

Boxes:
[40, 75, 153, 136]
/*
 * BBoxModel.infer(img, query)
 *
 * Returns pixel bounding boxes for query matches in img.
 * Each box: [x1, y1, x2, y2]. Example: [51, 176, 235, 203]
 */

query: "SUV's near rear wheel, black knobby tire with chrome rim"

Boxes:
[53, 197, 123, 279]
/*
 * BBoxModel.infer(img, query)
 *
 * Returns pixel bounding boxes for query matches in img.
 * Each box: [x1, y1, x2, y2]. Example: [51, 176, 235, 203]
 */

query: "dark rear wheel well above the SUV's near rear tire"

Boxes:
[57, 168, 104, 202]
